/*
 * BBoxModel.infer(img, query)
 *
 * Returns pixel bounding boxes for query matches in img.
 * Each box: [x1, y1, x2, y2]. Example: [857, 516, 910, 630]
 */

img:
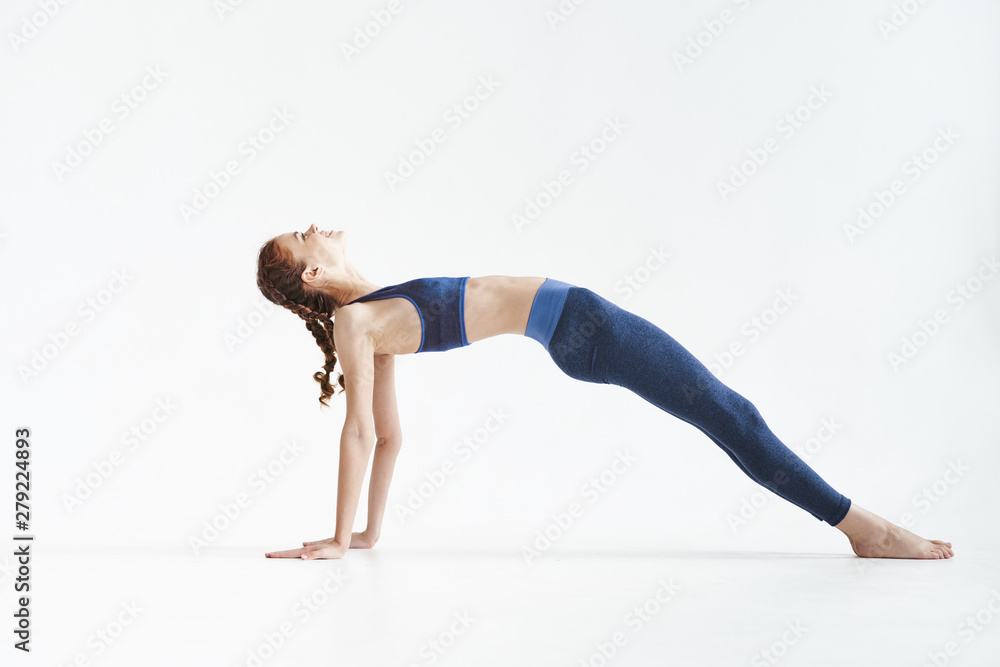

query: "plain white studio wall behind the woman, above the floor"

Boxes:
[0, 0, 1000, 660]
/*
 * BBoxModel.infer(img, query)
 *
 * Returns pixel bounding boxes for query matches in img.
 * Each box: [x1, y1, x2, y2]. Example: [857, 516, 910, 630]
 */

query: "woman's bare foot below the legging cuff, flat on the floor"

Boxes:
[836, 502, 955, 558]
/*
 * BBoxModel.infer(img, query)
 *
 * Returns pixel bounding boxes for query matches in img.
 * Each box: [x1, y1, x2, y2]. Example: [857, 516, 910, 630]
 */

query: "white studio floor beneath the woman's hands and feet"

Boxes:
[25, 538, 1000, 667]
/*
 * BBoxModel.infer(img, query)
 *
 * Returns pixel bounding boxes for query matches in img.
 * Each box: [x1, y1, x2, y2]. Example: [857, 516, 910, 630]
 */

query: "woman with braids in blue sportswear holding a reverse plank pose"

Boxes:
[257, 225, 954, 559]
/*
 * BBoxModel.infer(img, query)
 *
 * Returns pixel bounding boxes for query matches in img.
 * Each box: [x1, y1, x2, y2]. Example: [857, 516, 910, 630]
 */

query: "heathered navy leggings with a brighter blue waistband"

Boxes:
[524, 278, 851, 526]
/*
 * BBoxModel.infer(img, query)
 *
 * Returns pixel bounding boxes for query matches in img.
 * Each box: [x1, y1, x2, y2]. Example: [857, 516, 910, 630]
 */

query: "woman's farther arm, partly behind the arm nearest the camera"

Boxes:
[362, 354, 403, 548]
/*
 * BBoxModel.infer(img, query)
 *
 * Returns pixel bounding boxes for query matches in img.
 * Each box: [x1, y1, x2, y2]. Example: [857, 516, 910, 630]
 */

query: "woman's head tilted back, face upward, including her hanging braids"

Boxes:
[257, 225, 350, 406]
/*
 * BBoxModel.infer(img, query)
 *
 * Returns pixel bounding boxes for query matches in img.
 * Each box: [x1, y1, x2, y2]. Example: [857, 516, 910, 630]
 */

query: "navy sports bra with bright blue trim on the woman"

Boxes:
[344, 276, 469, 352]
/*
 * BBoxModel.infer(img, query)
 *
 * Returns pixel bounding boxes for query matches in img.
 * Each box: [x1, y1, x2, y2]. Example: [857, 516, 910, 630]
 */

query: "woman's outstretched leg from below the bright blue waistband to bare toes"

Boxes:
[542, 287, 954, 559]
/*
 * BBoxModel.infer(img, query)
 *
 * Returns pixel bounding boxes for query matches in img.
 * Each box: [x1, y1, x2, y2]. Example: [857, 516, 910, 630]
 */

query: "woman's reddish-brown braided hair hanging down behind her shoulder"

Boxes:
[257, 238, 347, 407]
